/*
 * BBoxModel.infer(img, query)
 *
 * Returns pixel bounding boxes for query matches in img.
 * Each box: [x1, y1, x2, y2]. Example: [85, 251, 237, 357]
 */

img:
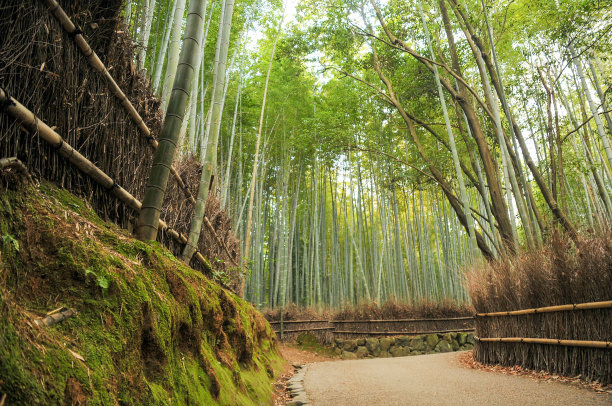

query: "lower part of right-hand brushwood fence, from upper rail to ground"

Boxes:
[474, 301, 612, 384]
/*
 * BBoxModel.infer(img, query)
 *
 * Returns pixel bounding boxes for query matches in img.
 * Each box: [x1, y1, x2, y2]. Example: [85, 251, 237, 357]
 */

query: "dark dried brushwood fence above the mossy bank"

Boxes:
[0, 0, 239, 288]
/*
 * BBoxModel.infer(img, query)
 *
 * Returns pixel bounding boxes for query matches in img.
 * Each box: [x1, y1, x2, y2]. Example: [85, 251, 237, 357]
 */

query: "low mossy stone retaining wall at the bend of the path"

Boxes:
[334, 333, 474, 359]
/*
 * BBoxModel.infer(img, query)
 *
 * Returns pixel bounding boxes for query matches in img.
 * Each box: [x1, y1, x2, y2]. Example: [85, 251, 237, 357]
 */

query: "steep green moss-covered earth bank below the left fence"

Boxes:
[0, 183, 283, 405]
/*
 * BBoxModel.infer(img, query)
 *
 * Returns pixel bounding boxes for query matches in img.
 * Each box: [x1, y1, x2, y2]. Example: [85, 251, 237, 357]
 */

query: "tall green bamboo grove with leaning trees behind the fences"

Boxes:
[124, 0, 612, 307]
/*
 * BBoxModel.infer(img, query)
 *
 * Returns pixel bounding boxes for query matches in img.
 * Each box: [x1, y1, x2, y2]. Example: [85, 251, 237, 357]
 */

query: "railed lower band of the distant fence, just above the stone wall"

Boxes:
[270, 316, 474, 342]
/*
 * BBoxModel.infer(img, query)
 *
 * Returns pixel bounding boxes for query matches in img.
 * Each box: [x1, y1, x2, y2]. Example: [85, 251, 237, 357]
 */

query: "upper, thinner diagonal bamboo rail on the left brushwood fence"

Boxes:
[41, 0, 238, 266]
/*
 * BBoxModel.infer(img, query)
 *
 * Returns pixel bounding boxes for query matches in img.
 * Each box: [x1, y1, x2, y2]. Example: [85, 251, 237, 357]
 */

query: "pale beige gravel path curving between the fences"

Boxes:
[304, 353, 612, 406]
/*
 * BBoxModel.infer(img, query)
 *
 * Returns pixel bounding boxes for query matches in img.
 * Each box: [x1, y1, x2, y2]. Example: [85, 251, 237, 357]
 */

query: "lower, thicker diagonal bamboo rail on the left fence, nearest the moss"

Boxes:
[0, 88, 211, 270]
